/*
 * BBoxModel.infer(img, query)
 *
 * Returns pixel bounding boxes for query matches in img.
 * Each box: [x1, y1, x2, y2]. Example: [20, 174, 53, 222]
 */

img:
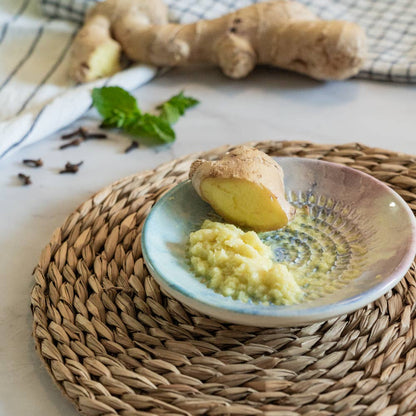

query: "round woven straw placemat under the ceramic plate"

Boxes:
[32, 142, 416, 416]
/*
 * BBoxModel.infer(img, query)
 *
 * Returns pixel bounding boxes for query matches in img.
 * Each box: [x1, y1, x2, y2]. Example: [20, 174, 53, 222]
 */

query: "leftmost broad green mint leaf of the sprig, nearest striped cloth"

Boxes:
[92, 87, 141, 128]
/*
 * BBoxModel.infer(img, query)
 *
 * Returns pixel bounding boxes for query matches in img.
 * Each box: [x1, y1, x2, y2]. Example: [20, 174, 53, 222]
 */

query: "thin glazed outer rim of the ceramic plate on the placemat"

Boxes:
[141, 157, 416, 327]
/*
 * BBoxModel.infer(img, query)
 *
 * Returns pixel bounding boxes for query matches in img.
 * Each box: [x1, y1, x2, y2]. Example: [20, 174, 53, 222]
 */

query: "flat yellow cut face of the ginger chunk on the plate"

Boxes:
[201, 178, 289, 231]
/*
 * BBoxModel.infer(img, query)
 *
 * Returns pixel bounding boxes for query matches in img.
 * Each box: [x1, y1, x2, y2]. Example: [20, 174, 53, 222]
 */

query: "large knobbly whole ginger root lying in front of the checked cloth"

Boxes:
[70, 0, 366, 82]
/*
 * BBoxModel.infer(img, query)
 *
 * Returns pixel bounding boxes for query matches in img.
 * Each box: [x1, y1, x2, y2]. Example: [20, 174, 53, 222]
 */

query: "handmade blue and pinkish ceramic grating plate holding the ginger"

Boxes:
[142, 158, 416, 327]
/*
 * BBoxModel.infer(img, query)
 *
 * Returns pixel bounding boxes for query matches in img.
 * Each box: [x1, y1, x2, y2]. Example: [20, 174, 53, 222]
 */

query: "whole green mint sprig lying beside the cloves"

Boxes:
[92, 87, 199, 144]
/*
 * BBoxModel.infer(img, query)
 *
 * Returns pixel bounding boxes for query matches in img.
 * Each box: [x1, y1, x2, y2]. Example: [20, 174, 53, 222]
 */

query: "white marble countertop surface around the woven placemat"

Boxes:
[0, 69, 416, 416]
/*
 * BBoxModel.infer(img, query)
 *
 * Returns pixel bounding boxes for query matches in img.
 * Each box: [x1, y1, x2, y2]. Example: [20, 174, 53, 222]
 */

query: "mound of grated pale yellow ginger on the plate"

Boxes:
[189, 220, 303, 304]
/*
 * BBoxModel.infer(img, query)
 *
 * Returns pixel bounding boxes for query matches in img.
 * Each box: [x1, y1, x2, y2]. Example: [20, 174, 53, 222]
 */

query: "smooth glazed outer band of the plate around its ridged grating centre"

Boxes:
[142, 158, 416, 327]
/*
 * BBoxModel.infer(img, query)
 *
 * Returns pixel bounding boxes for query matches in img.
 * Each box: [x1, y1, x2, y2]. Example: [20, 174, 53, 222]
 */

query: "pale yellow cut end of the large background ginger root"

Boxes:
[87, 39, 121, 81]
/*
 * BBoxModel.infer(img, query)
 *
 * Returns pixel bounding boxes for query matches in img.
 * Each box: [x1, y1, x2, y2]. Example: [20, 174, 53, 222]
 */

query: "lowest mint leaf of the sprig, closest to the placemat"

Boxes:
[125, 113, 176, 143]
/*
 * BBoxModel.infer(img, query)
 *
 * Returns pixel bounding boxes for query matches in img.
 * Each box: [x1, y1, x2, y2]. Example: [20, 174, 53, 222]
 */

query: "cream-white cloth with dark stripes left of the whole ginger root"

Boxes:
[0, 0, 156, 159]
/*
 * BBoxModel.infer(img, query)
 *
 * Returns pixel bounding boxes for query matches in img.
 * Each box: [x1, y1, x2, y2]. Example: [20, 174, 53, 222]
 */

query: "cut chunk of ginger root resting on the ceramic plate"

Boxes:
[189, 146, 295, 231]
